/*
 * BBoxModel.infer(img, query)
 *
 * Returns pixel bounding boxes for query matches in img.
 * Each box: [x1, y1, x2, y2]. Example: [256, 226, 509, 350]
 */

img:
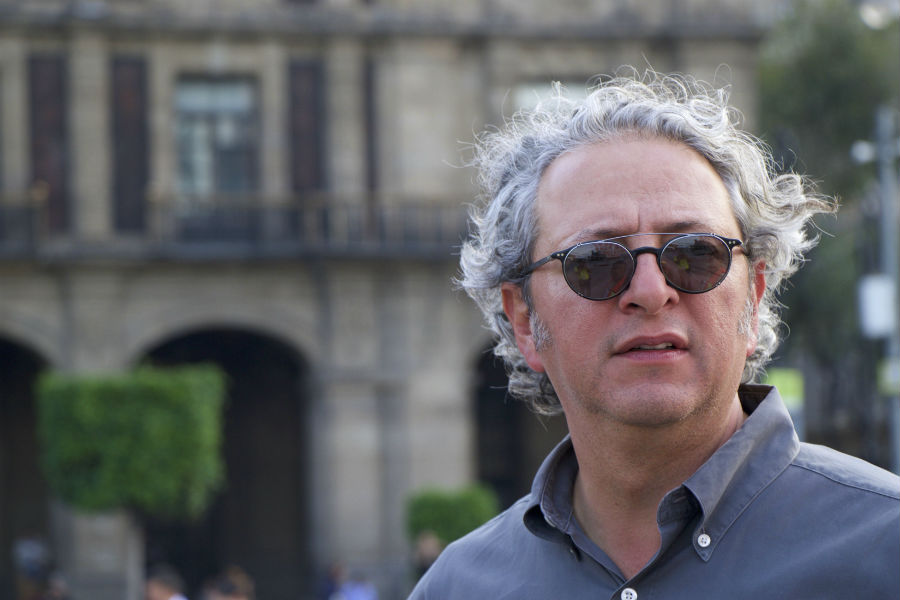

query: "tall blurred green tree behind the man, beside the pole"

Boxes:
[759, 0, 900, 464]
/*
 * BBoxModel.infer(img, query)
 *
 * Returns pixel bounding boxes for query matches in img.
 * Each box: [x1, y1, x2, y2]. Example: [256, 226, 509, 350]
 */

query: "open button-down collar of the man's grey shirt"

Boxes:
[524, 385, 800, 560]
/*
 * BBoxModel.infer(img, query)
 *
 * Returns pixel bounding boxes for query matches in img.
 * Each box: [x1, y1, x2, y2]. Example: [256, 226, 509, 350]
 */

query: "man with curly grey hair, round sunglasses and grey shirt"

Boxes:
[411, 74, 900, 600]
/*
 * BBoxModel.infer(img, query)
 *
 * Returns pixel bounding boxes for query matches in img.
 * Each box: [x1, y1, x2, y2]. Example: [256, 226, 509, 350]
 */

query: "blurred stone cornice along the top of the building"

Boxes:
[0, 2, 767, 42]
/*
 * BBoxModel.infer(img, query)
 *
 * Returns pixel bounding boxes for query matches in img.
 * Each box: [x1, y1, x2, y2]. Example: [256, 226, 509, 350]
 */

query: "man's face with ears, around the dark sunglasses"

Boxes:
[503, 138, 764, 427]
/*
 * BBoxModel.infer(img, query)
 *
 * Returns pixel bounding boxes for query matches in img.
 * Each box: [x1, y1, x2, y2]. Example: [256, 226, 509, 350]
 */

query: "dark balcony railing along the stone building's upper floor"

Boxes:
[0, 198, 465, 260]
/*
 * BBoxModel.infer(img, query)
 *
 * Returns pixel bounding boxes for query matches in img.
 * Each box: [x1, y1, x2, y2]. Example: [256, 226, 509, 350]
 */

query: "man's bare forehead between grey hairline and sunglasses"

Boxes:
[534, 137, 741, 251]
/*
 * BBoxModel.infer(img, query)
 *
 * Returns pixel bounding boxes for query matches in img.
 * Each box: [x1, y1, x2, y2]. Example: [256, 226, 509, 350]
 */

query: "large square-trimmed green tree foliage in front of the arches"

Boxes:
[37, 365, 225, 518]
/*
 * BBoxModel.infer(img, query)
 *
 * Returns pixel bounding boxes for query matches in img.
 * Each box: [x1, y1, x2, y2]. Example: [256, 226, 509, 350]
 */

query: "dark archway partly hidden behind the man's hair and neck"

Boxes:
[475, 351, 567, 508]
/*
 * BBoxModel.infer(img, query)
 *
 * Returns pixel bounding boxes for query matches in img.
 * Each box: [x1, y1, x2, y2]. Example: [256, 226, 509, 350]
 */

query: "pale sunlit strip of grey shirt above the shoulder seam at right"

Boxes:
[792, 443, 900, 500]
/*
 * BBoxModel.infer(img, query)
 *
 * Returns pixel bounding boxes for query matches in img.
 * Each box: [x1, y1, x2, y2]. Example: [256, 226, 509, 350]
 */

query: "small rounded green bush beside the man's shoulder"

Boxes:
[406, 485, 499, 545]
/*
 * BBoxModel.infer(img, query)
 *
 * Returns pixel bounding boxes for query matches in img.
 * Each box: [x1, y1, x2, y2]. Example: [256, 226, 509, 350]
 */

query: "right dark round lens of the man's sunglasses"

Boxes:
[659, 235, 730, 292]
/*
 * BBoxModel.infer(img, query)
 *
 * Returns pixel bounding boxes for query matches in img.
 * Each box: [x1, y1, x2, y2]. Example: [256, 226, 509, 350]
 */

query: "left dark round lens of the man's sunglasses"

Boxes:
[563, 242, 634, 300]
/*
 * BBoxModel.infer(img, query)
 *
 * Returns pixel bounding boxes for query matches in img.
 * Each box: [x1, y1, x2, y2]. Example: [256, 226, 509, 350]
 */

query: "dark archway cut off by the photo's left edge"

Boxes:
[0, 338, 50, 598]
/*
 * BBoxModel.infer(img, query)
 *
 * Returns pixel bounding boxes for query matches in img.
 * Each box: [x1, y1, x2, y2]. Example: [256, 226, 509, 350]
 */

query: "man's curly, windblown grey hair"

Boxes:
[458, 71, 835, 414]
